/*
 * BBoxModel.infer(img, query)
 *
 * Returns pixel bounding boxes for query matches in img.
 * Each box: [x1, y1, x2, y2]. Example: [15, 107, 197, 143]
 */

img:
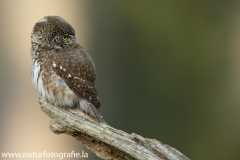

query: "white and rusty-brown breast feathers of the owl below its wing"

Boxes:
[32, 60, 79, 107]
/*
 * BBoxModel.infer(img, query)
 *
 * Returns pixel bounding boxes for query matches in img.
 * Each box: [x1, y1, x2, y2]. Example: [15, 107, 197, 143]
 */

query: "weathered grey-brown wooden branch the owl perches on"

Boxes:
[39, 99, 189, 160]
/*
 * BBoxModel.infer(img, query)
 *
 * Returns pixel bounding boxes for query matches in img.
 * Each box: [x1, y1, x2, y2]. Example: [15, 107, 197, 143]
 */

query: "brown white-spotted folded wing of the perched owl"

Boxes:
[48, 45, 101, 109]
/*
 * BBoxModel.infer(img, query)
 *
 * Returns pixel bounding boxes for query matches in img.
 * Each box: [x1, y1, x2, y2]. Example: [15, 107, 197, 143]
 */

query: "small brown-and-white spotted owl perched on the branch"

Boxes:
[31, 16, 105, 123]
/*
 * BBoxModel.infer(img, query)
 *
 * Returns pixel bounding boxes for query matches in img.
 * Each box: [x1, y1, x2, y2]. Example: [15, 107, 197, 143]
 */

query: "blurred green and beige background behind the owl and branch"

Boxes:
[0, 0, 240, 160]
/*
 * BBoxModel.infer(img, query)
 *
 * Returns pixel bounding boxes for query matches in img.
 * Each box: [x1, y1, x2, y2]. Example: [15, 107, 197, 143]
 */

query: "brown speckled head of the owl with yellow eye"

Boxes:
[31, 16, 75, 49]
